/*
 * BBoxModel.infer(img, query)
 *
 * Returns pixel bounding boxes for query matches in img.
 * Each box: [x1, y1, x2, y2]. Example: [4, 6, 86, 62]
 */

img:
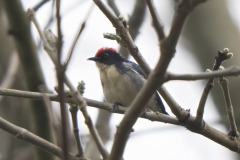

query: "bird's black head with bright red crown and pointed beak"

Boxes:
[88, 47, 126, 65]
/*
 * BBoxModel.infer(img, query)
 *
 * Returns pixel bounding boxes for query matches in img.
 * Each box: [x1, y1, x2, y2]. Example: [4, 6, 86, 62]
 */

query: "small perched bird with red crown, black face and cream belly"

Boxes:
[87, 47, 168, 115]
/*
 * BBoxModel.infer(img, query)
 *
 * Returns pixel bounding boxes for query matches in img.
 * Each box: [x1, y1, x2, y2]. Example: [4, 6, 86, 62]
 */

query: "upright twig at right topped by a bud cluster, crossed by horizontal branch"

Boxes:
[195, 48, 232, 127]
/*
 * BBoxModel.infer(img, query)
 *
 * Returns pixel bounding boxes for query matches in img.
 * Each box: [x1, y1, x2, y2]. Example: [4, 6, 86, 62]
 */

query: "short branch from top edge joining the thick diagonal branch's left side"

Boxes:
[146, 0, 166, 42]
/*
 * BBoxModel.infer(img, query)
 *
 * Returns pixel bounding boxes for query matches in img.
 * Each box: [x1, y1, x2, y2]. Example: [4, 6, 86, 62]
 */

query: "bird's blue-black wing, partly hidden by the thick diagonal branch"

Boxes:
[128, 61, 168, 114]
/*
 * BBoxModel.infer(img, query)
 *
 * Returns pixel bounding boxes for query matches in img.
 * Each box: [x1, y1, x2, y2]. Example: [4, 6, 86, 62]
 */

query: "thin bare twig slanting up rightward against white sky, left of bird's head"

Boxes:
[64, 5, 94, 67]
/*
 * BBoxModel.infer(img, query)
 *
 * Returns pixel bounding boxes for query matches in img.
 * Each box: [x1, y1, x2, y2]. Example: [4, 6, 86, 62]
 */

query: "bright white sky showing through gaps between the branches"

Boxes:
[22, 0, 240, 160]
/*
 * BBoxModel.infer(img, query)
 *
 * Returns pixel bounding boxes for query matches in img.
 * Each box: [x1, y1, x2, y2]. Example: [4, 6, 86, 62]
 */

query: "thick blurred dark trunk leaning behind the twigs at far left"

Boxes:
[2, 0, 53, 159]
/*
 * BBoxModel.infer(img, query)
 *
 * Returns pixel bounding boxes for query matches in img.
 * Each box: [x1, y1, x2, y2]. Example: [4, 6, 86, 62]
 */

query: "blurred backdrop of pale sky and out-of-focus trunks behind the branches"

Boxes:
[0, 0, 240, 160]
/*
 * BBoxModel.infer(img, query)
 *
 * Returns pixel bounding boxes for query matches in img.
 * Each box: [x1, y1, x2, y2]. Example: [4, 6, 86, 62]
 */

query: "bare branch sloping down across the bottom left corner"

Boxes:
[0, 117, 78, 160]
